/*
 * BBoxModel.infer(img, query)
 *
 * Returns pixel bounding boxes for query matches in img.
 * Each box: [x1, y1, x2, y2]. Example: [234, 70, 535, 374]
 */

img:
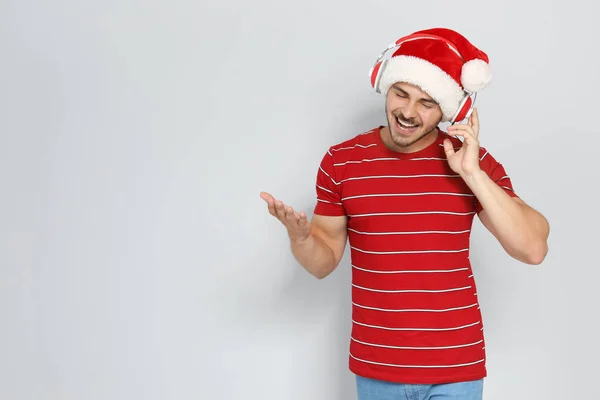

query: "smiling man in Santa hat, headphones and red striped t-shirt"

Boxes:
[261, 29, 549, 400]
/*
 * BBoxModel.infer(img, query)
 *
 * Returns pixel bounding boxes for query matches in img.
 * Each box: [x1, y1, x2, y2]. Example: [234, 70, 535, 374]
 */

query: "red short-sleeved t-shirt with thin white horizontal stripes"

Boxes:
[314, 127, 517, 384]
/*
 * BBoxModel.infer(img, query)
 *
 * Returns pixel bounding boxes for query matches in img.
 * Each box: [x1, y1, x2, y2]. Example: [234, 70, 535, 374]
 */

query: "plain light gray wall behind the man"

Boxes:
[0, 0, 600, 400]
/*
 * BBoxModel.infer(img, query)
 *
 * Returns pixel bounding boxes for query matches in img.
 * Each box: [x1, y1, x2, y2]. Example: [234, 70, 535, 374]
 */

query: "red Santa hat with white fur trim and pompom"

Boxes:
[372, 28, 492, 121]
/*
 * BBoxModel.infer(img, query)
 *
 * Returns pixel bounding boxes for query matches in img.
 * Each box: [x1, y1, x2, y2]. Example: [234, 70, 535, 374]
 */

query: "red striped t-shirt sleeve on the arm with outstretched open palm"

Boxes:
[314, 148, 346, 216]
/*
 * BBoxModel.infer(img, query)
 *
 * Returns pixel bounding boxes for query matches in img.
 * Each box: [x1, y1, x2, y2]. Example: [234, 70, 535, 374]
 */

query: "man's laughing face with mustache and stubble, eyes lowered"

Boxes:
[385, 82, 442, 148]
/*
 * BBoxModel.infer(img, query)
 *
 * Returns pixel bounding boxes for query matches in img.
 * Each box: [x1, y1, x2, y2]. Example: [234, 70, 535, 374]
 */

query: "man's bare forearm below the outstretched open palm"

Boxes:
[290, 234, 337, 279]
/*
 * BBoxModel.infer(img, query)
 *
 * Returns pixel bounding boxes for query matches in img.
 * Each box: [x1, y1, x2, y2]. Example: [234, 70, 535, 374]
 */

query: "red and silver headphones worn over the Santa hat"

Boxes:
[369, 33, 477, 125]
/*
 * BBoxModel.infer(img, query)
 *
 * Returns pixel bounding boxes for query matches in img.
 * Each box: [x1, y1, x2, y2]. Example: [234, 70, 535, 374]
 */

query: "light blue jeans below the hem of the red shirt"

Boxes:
[356, 376, 483, 400]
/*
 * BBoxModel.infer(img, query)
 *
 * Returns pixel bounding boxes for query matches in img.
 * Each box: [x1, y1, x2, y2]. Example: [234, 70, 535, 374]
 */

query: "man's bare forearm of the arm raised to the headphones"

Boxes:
[463, 170, 549, 264]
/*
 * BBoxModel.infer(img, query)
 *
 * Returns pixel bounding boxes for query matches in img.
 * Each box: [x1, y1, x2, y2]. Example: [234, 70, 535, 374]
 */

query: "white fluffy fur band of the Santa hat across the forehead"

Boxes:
[379, 56, 465, 121]
